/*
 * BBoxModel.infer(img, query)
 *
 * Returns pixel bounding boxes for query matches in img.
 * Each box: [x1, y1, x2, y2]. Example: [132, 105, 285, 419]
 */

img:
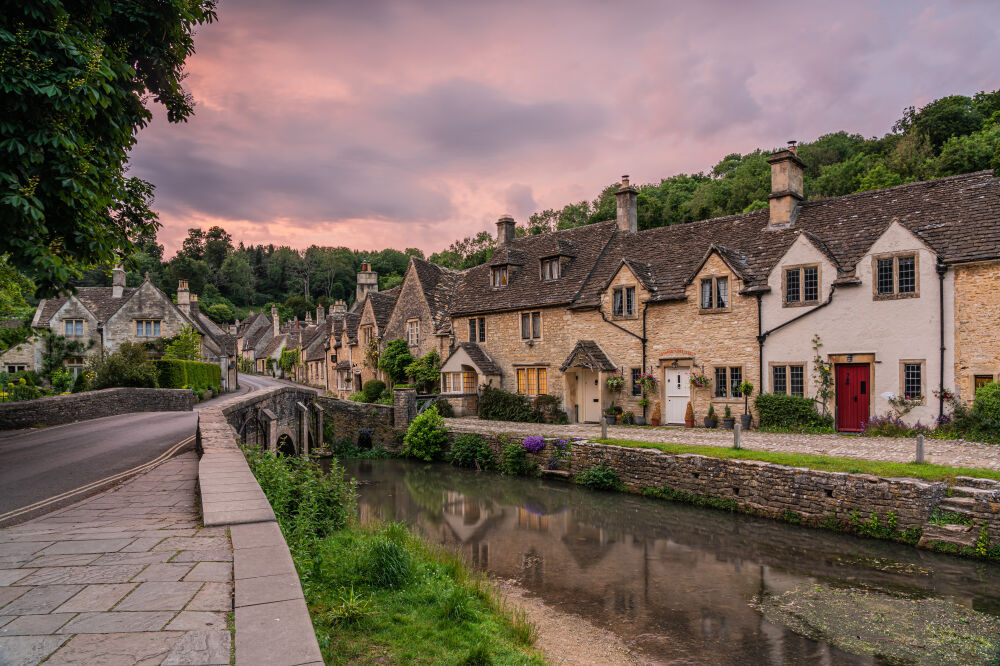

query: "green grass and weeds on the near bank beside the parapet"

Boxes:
[243, 440, 544, 664]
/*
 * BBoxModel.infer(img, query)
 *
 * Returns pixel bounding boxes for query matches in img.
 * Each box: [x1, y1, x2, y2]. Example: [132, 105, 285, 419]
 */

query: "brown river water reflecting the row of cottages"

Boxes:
[347, 460, 1000, 664]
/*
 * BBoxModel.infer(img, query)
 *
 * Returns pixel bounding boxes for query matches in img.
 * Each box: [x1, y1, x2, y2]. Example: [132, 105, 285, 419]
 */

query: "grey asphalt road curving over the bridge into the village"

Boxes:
[0, 375, 290, 525]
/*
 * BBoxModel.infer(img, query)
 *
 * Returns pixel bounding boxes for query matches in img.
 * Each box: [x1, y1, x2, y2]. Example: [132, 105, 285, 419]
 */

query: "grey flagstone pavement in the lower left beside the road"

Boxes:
[0, 452, 233, 666]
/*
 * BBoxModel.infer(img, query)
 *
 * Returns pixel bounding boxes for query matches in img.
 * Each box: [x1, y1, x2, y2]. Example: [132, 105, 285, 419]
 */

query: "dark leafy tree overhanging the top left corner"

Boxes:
[0, 0, 216, 296]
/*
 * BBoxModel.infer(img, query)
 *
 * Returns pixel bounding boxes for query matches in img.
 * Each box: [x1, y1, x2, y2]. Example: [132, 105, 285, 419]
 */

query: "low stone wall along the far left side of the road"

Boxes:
[0, 388, 194, 430]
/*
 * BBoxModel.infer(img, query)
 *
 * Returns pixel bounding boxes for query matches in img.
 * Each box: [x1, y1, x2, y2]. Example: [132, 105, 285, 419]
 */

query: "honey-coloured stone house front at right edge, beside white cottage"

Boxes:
[955, 261, 1000, 403]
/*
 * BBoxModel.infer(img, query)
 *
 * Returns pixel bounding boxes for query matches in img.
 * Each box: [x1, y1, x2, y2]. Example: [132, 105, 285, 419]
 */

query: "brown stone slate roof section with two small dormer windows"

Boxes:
[452, 221, 621, 315]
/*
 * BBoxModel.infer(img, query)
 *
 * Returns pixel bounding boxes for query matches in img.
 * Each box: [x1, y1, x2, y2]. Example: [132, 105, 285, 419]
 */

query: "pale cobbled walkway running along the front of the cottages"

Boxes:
[447, 418, 1000, 470]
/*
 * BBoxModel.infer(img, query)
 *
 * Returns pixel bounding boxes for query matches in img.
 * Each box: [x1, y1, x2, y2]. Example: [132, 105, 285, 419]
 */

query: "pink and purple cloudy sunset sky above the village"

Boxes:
[131, 0, 1000, 256]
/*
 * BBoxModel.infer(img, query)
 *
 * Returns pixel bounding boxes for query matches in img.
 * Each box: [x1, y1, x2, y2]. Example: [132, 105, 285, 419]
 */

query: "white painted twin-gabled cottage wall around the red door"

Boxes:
[761, 222, 955, 424]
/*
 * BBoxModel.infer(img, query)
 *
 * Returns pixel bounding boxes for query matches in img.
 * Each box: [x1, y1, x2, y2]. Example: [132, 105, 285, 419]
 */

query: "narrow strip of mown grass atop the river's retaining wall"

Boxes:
[594, 439, 1000, 481]
